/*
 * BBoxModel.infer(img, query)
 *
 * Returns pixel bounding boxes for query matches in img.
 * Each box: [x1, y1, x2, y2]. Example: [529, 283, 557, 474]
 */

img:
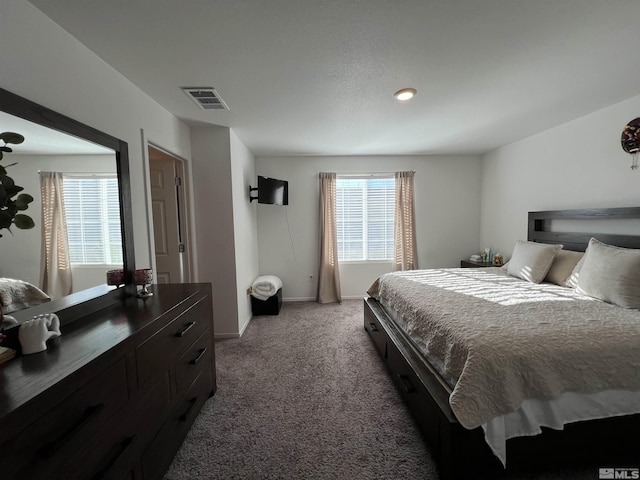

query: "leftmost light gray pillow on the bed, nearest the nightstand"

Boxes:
[507, 240, 562, 283]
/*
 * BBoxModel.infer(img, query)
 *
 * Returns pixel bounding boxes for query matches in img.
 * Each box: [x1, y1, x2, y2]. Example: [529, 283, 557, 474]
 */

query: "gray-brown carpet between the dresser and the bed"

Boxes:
[165, 300, 598, 480]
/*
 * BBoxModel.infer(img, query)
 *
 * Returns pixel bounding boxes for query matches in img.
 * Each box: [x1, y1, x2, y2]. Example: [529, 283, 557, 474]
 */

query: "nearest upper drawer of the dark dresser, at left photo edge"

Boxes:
[0, 359, 128, 479]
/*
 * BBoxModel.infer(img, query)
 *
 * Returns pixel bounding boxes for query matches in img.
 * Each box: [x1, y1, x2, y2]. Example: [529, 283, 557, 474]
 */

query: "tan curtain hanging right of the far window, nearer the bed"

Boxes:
[394, 172, 418, 270]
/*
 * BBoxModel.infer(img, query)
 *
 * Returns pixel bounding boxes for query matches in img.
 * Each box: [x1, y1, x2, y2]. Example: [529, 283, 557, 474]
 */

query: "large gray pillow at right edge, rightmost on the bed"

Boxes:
[576, 238, 640, 308]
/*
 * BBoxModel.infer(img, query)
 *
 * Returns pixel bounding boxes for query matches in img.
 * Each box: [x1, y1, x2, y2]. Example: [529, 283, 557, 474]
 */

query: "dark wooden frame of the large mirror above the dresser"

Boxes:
[0, 88, 135, 320]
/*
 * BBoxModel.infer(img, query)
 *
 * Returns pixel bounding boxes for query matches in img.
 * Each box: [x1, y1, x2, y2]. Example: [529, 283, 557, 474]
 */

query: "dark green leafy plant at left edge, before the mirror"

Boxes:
[0, 132, 35, 237]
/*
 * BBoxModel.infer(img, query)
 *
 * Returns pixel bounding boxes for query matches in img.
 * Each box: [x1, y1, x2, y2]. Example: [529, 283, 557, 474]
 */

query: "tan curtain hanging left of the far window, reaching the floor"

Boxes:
[316, 173, 342, 303]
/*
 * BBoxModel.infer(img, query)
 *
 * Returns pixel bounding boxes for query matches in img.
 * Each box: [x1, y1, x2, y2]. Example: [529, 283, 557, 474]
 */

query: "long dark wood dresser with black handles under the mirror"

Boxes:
[0, 284, 216, 479]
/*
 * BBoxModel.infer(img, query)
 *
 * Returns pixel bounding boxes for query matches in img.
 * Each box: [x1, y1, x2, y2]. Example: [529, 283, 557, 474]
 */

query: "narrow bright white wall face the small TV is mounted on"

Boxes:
[230, 130, 258, 334]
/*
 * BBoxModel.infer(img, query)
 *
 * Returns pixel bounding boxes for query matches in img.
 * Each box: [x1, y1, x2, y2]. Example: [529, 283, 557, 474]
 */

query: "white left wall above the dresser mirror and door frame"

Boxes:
[0, 0, 191, 267]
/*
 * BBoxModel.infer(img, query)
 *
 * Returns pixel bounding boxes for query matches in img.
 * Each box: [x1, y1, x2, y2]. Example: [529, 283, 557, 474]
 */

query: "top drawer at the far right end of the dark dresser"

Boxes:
[136, 297, 211, 386]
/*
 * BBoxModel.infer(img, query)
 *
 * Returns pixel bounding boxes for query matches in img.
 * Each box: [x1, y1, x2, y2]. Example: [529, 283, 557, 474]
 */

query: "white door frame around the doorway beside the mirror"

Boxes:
[142, 137, 198, 283]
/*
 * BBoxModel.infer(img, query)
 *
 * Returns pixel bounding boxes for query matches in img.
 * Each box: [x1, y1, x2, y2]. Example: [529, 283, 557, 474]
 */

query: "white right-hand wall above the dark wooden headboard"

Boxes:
[481, 96, 640, 258]
